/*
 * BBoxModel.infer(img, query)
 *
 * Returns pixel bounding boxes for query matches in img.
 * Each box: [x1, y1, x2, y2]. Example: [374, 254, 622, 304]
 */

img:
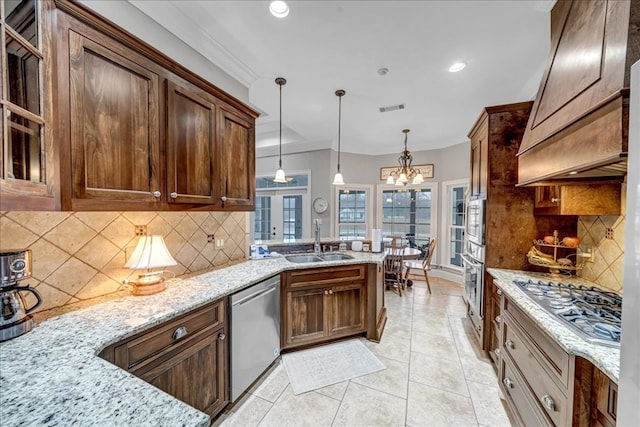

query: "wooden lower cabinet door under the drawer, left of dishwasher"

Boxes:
[135, 327, 229, 416]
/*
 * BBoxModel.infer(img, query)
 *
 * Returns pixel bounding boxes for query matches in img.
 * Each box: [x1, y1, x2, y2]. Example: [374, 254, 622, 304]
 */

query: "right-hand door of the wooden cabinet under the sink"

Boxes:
[328, 283, 367, 335]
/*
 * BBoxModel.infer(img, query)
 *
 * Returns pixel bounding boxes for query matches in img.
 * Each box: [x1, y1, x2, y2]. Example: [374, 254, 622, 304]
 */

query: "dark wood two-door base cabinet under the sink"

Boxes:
[281, 265, 368, 350]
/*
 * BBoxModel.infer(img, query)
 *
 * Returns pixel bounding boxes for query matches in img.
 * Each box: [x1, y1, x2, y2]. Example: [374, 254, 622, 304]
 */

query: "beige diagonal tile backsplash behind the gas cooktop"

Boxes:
[578, 185, 627, 292]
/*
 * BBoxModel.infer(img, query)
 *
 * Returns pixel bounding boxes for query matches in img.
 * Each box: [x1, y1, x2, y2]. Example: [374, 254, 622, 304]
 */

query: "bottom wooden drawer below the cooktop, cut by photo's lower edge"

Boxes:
[500, 357, 552, 426]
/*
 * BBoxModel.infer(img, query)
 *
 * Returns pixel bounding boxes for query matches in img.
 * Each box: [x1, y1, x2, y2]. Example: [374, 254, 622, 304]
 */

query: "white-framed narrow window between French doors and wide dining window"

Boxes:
[335, 185, 372, 240]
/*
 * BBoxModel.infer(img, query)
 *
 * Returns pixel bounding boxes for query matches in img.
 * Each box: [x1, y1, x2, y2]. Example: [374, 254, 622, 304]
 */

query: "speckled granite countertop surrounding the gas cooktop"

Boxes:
[487, 268, 620, 384]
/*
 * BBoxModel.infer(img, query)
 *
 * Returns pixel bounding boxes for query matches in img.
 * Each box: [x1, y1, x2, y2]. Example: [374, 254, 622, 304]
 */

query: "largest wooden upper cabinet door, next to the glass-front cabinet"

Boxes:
[69, 31, 161, 210]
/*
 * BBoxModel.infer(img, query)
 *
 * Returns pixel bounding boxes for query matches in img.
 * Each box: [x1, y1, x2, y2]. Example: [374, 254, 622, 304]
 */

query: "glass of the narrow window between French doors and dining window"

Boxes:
[338, 189, 367, 240]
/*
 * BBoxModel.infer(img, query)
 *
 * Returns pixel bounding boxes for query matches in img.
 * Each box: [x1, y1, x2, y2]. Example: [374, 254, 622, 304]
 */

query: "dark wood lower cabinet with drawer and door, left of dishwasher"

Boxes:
[100, 299, 229, 418]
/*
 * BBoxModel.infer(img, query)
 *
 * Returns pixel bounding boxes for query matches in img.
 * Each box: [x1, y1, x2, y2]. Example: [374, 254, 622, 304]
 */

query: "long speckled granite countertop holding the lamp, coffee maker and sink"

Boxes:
[0, 252, 383, 427]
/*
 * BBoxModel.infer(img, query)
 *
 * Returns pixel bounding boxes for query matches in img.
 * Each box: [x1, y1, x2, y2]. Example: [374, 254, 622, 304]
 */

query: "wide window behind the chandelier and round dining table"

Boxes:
[378, 184, 436, 254]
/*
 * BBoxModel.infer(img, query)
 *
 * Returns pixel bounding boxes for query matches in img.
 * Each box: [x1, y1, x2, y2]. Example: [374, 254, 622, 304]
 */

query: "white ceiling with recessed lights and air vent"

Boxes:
[129, 0, 555, 154]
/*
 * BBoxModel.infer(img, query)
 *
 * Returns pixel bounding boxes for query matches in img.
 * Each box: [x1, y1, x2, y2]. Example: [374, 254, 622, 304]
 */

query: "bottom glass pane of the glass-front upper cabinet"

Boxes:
[3, 110, 44, 182]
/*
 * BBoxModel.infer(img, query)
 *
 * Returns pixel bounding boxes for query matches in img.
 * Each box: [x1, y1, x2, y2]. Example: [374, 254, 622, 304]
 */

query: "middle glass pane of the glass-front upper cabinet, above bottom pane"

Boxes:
[4, 34, 40, 115]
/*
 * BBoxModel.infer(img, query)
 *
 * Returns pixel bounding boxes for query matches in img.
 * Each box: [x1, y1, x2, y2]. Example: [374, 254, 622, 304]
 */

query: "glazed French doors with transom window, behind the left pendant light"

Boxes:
[251, 173, 310, 242]
